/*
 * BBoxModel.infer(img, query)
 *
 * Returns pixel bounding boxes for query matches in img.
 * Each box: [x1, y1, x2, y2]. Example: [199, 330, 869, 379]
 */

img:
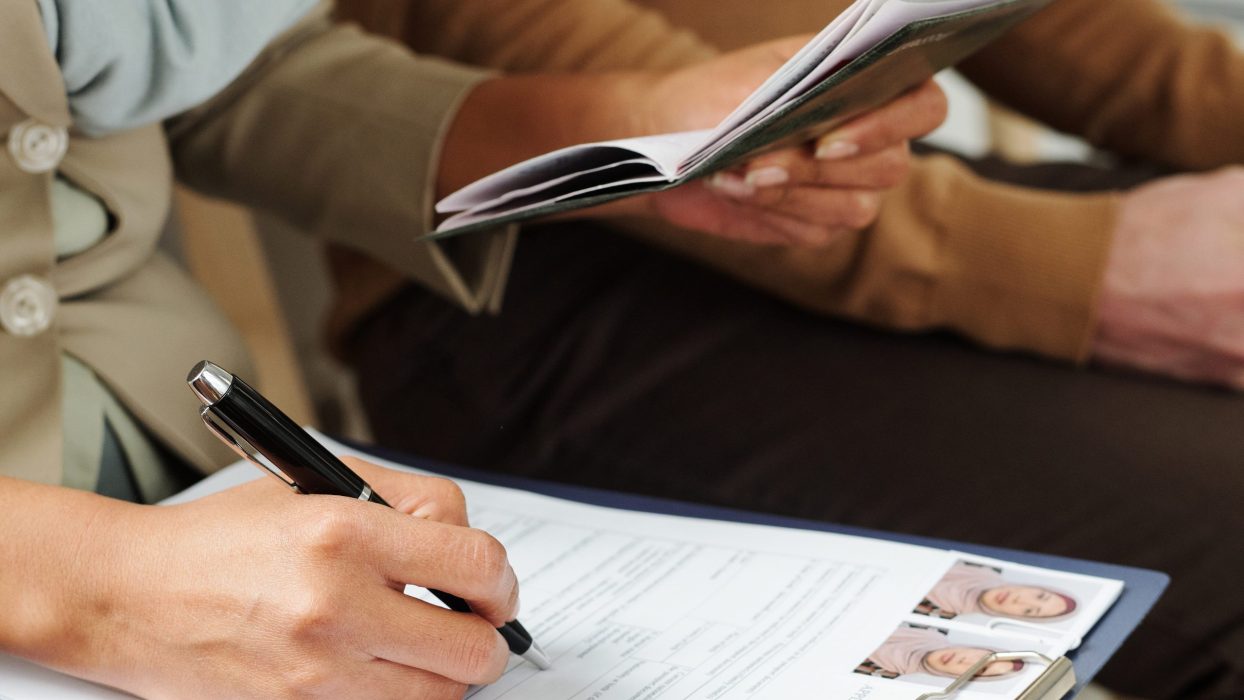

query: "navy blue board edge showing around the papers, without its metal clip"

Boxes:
[341, 440, 1171, 698]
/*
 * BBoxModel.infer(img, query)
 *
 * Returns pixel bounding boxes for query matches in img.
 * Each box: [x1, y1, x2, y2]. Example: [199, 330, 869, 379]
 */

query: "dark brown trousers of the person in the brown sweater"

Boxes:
[351, 154, 1244, 700]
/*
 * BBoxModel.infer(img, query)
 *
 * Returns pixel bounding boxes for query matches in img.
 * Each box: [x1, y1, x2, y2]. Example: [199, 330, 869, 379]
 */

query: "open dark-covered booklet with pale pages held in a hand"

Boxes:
[429, 0, 1051, 239]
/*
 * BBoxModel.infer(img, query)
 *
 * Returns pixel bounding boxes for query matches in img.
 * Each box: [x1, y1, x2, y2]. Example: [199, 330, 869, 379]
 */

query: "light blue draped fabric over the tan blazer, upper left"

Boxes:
[36, 0, 316, 136]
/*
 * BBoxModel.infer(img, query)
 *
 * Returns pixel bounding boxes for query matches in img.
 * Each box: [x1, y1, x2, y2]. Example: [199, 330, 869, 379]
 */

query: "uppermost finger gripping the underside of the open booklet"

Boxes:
[816, 81, 948, 160]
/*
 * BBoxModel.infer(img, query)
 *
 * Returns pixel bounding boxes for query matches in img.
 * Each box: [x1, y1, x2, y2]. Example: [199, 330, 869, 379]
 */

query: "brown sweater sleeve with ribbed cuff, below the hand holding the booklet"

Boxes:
[627, 157, 1117, 361]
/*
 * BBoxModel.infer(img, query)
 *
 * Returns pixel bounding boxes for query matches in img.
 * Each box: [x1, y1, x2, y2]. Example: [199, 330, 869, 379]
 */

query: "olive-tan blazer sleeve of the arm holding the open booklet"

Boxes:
[168, 4, 513, 311]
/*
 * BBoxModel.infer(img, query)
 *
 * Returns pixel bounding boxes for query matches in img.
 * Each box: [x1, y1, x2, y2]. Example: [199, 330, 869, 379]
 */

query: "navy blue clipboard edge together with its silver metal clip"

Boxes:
[350, 438, 1171, 700]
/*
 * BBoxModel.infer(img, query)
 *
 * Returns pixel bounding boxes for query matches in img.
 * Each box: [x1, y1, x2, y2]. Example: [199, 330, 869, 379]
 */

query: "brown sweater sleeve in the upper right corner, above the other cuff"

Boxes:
[962, 0, 1244, 169]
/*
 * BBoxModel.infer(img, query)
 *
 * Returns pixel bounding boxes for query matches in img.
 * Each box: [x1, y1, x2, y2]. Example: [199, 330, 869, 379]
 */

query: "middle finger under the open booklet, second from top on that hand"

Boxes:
[743, 140, 912, 190]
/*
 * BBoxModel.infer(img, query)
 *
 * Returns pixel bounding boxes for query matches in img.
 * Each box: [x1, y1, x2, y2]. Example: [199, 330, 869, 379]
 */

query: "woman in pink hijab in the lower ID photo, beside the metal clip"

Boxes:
[856, 625, 1024, 683]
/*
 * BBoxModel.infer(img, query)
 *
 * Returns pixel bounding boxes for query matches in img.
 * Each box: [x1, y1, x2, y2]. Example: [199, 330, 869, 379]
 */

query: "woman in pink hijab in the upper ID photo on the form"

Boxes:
[914, 561, 1080, 623]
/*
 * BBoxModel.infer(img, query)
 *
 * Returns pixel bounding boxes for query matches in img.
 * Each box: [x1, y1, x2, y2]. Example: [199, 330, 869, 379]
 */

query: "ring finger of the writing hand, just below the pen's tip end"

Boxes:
[363, 591, 510, 684]
